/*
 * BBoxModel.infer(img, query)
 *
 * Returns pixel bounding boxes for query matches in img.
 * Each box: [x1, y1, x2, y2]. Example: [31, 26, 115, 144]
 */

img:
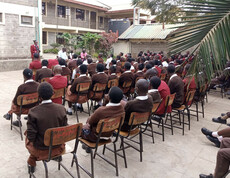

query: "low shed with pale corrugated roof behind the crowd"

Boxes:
[113, 24, 183, 57]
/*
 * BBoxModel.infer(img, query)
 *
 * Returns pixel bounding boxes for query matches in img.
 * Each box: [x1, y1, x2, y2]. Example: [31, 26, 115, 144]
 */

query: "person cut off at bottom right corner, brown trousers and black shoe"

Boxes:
[199, 138, 230, 178]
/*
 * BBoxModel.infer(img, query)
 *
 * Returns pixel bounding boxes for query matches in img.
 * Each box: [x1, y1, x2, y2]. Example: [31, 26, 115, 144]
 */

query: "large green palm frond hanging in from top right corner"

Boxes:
[169, 0, 230, 84]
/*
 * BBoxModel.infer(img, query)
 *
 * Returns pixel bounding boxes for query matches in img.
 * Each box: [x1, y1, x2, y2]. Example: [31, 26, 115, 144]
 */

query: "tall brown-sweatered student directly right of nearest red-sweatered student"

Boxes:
[167, 65, 184, 108]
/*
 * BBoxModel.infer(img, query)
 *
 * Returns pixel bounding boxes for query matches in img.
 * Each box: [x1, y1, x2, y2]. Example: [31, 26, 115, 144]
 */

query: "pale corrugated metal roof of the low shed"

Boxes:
[118, 24, 184, 40]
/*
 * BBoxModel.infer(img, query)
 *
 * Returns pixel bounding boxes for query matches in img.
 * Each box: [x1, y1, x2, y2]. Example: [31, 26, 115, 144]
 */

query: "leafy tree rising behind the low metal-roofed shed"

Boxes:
[132, 0, 183, 23]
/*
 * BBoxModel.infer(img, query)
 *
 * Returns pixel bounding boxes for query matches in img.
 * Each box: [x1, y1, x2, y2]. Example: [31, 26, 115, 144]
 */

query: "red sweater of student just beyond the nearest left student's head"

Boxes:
[48, 75, 67, 104]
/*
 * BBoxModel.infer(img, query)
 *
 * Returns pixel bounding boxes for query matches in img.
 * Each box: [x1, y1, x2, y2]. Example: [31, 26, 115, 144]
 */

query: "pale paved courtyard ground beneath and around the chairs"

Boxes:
[0, 71, 230, 178]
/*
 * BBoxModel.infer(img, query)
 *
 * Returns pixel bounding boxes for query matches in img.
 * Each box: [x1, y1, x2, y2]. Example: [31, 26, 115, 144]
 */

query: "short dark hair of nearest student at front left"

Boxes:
[38, 82, 53, 100]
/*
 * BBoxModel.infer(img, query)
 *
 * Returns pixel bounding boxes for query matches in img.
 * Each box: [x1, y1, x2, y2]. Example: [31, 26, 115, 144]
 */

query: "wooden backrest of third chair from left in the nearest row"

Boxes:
[128, 112, 150, 126]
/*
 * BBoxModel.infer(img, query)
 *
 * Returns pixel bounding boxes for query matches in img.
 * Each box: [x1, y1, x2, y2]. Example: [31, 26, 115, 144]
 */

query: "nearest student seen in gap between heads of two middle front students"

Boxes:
[119, 62, 134, 88]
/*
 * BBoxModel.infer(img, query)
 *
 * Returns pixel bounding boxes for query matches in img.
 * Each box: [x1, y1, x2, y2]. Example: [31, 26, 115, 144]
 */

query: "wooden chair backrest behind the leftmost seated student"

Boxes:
[17, 93, 38, 106]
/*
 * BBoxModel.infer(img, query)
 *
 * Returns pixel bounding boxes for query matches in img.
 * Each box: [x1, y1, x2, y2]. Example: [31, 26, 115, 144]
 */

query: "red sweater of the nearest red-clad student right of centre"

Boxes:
[157, 80, 172, 115]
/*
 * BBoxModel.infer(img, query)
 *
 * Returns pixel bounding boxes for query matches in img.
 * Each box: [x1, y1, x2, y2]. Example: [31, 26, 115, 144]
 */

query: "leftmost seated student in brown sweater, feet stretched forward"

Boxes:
[3, 69, 39, 126]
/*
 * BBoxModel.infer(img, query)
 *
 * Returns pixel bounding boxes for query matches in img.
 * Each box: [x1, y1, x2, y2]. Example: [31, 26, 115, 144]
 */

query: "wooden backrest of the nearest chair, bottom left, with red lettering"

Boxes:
[44, 123, 82, 146]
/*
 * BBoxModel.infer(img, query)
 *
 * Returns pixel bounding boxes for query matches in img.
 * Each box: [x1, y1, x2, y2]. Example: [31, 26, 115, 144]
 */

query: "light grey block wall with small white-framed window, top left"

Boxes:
[0, 0, 37, 60]
